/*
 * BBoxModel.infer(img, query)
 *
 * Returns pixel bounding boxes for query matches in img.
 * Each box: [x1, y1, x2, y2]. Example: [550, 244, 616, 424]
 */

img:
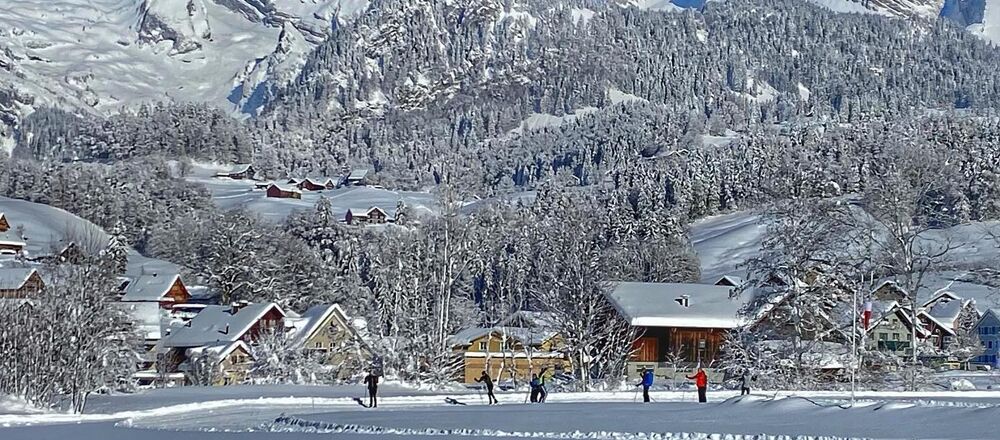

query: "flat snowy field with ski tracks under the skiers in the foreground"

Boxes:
[0, 386, 1000, 440]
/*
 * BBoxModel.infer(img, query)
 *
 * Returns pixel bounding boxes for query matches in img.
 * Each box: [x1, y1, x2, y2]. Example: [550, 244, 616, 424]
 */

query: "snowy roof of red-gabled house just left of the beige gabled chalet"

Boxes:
[163, 303, 285, 347]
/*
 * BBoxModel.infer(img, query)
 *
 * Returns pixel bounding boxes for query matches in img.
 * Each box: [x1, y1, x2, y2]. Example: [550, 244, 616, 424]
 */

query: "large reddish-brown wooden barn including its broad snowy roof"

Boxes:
[608, 282, 750, 375]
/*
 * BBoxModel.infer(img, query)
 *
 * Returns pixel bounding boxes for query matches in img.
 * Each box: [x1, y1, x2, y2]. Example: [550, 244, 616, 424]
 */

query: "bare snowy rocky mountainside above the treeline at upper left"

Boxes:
[0, 0, 368, 137]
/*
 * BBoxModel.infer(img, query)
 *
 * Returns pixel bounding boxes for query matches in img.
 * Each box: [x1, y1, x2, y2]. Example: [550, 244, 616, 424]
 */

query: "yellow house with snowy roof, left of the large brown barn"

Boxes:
[449, 312, 572, 384]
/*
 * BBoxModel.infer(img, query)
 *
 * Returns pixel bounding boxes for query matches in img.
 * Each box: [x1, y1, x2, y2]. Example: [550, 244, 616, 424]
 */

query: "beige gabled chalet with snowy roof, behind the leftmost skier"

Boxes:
[284, 304, 372, 375]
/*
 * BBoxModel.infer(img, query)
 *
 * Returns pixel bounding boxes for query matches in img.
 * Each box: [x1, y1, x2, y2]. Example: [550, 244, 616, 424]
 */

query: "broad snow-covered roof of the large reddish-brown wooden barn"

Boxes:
[608, 282, 749, 328]
